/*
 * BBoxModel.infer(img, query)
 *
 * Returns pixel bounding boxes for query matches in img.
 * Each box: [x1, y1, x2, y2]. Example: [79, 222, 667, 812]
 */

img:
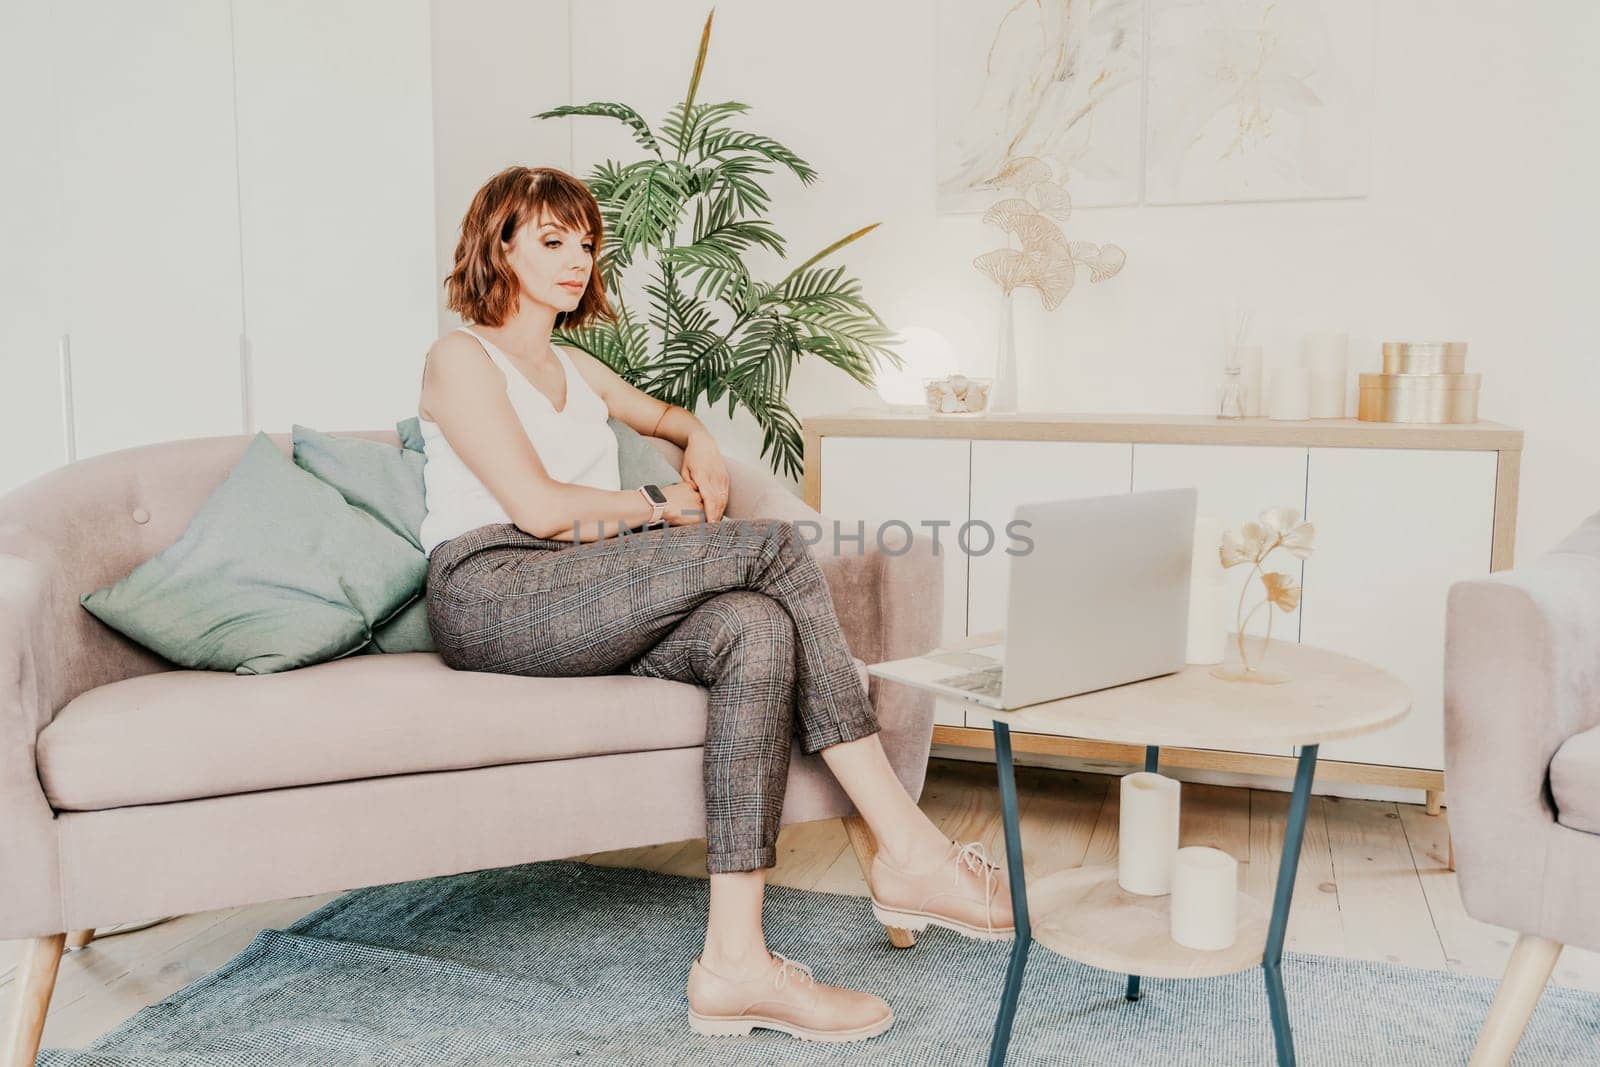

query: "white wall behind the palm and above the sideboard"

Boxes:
[434, 0, 1600, 558]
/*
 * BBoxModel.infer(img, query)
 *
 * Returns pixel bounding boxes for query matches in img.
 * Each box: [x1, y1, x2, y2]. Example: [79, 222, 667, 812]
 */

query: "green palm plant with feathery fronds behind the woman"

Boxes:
[536, 16, 901, 477]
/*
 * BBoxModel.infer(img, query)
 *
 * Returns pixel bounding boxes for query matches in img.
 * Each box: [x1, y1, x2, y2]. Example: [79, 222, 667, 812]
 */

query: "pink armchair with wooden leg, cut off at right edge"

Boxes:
[1445, 514, 1600, 1067]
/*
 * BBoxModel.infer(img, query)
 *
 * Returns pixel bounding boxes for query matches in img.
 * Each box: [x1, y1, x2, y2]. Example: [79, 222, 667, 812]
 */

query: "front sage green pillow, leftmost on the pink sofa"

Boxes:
[80, 434, 427, 675]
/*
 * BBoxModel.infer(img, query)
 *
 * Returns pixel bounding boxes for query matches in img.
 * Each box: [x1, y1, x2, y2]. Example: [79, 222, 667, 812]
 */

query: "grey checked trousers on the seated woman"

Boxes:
[427, 518, 878, 873]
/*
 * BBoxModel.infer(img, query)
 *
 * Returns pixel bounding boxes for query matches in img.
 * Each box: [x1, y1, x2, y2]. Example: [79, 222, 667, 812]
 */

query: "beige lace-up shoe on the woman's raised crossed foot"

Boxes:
[867, 841, 1016, 941]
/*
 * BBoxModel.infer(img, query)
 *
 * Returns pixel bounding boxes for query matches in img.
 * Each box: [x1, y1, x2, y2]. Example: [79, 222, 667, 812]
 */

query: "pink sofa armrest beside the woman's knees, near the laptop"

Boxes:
[726, 459, 944, 800]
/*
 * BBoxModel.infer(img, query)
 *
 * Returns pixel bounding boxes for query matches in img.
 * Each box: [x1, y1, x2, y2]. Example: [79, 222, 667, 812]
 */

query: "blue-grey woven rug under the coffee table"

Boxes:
[40, 861, 1600, 1067]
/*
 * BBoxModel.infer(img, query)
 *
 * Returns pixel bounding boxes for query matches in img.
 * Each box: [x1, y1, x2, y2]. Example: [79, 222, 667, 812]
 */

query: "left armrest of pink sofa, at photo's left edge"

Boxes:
[0, 555, 62, 939]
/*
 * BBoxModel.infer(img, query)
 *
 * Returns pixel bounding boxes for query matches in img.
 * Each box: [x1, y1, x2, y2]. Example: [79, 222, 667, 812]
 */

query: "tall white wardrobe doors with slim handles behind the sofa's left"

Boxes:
[0, 0, 437, 493]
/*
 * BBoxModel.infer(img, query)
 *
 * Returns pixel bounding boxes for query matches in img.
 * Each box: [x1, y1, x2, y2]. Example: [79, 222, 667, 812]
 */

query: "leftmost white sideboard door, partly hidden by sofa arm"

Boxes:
[818, 437, 971, 726]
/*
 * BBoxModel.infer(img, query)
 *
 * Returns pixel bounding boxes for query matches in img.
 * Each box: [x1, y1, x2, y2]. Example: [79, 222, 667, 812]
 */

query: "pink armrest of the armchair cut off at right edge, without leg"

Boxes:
[1445, 552, 1600, 939]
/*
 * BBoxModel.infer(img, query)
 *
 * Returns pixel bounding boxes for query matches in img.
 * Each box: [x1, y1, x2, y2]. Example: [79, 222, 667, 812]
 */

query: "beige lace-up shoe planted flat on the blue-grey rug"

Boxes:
[688, 952, 894, 1041]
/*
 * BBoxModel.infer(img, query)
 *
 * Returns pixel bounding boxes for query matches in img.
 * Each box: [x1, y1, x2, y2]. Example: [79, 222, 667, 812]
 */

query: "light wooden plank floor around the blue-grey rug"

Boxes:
[0, 760, 1600, 1046]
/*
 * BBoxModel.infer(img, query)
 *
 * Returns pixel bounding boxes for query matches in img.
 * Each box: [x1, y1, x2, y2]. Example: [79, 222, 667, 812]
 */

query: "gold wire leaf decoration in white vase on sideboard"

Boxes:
[973, 155, 1128, 310]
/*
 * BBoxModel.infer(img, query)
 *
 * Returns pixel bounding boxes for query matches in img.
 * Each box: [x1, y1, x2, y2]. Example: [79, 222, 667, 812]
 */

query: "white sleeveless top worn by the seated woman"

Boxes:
[418, 326, 622, 555]
